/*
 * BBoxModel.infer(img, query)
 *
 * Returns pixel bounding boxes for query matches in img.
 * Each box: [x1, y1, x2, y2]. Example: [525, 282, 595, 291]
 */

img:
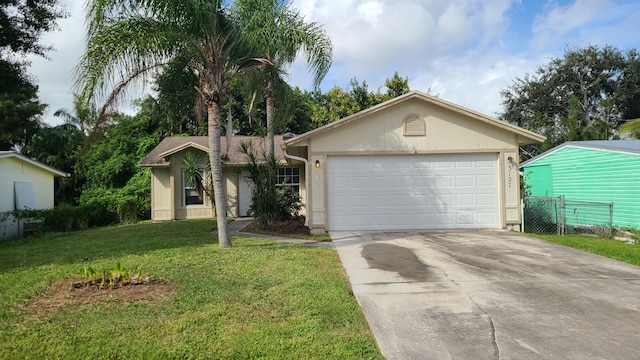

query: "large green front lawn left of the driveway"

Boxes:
[0, 220, 382, 359]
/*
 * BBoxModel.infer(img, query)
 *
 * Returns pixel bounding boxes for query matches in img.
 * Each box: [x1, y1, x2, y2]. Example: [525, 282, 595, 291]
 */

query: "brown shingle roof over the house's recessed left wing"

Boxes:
[138, 135, 283, 167]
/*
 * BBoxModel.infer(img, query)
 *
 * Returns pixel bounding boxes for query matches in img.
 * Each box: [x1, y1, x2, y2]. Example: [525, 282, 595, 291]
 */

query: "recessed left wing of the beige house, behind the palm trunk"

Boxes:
[139, 136, 305, 221]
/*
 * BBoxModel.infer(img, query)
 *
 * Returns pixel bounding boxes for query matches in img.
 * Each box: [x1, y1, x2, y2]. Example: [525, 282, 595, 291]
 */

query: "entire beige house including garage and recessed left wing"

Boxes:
[140, 91, 545, 233]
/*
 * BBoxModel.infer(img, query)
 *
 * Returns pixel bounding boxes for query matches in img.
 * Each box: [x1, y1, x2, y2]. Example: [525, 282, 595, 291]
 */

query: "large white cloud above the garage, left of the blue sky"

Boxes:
[291, 0, 512, 112]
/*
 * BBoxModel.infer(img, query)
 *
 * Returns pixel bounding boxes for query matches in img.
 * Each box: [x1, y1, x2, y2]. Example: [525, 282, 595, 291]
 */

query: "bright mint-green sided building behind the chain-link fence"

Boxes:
[524, 147, 640, 228]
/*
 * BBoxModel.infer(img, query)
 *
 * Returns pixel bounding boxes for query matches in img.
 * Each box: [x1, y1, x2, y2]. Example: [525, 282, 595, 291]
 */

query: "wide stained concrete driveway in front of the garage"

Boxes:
[331, 230, 640, 360]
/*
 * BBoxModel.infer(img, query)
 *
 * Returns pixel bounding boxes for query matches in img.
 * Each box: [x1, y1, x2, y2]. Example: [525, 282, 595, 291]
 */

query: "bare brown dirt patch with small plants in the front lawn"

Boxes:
[20, 279, 173, 318]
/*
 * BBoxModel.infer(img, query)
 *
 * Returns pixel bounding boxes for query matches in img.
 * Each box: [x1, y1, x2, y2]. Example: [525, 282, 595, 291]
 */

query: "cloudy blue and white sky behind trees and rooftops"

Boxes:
[29, 0, 640, 125]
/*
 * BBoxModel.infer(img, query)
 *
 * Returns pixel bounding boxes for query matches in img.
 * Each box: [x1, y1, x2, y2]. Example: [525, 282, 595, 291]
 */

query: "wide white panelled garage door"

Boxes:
[327, 153, 499, 230]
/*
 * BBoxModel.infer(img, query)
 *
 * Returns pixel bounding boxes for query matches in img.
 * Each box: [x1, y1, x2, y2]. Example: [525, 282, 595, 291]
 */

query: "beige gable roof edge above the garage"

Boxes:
[284, 91, 546, 146]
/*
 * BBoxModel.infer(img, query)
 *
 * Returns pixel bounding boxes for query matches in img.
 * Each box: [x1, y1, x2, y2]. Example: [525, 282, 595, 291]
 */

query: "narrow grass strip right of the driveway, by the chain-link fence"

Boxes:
[532, 235, 640, 266]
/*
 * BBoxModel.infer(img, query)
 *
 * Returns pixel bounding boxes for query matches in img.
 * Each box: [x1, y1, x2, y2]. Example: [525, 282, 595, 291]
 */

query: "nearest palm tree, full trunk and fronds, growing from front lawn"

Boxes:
[76, 0, 266, 247]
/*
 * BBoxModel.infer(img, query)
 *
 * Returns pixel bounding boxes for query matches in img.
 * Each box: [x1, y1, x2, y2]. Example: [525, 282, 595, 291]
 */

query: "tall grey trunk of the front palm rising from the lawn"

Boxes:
[207, 101, 231, 247]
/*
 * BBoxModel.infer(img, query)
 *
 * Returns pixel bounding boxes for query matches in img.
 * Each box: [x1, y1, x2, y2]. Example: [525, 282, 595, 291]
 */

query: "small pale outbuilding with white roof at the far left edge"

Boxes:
[0, 151, 69, 239]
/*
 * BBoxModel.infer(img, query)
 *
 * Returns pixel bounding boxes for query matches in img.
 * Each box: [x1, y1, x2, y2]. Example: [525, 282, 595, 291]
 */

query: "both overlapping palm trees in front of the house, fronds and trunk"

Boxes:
[76, 0, 332, 247]
